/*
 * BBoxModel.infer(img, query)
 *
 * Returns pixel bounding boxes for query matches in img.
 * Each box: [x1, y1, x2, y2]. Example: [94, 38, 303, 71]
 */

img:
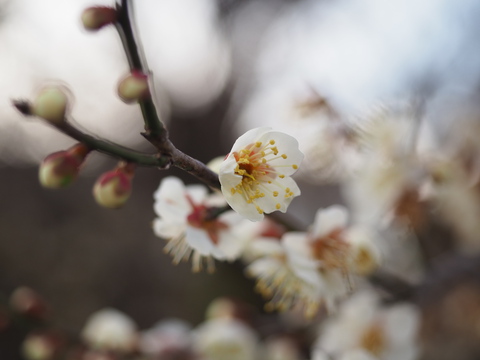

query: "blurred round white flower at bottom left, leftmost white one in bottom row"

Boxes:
[82, 308, 138, 352]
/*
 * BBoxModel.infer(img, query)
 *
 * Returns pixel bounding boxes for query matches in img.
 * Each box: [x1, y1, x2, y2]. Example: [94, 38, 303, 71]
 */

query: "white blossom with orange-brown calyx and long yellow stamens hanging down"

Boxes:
[246, 205, 380, 317]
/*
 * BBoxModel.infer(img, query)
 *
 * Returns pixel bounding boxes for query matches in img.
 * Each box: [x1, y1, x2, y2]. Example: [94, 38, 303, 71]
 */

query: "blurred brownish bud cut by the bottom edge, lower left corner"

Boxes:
[22, 333, 62, 360]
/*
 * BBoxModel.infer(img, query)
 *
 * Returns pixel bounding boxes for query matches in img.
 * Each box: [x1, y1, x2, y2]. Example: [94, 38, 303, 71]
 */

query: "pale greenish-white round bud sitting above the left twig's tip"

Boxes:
[31, 86, 68, 125]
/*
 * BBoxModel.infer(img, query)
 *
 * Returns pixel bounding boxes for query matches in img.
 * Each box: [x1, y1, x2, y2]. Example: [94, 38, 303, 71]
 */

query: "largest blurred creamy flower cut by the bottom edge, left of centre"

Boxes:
[194, 318, 258, 360]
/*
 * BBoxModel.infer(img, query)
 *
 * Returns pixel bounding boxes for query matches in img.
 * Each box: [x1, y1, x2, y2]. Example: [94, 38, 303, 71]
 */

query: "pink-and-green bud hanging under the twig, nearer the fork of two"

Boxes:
[93, 164, 133, 209]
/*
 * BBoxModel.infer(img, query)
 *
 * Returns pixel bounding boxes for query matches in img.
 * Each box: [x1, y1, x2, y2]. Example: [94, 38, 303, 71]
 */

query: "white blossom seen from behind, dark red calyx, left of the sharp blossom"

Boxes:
[153, 176, 249, 271]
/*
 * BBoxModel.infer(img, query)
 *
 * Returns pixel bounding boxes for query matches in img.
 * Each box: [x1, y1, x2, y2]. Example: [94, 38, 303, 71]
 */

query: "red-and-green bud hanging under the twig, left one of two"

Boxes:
[38, 144, 90, 189]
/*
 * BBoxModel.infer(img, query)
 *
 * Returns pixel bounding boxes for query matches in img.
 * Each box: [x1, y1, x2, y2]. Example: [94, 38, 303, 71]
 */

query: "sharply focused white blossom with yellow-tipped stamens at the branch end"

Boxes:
[219, 127, 303, 221]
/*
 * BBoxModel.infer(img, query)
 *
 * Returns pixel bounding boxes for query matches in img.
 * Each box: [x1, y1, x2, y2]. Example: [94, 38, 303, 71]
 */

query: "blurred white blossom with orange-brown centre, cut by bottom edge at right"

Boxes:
[316, 290, 420, 360]
